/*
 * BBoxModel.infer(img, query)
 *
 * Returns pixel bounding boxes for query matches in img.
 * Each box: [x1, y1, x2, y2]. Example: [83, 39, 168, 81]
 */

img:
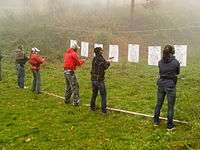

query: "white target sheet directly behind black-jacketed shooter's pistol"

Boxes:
[109, 45, 119, 62]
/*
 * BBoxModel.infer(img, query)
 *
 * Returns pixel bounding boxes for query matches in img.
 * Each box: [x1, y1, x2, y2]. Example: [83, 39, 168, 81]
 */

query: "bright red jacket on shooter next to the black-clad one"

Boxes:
[64, 48, 84, 71]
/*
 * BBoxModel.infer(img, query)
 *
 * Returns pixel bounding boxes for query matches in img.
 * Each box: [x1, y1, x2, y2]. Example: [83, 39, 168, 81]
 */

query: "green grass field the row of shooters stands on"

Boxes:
[0, 57, 200, 150]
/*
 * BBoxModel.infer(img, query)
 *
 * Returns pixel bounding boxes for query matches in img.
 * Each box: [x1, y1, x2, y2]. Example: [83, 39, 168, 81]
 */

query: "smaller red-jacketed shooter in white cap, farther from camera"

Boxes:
[29, 47, 45, 94]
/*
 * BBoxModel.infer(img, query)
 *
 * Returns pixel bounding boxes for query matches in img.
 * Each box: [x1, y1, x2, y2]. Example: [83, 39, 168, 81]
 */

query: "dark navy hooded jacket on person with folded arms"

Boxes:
[157, 56, 180, 87]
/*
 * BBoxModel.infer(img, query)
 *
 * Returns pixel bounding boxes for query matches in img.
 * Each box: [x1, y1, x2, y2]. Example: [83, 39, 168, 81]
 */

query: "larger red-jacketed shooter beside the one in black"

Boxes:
[64, 43, 84, 106]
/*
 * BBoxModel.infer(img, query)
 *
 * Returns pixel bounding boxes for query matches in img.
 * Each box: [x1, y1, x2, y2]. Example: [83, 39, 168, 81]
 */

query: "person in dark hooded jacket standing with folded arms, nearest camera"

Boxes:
[154, 45, 180, 130]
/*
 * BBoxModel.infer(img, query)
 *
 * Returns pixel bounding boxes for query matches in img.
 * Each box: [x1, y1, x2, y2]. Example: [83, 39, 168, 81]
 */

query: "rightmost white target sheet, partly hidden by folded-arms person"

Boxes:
[174, 45, 187, 67]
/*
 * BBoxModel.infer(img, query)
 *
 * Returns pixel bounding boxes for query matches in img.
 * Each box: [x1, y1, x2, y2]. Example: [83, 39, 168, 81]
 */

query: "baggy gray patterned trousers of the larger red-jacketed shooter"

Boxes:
[64, 70, 80, 105]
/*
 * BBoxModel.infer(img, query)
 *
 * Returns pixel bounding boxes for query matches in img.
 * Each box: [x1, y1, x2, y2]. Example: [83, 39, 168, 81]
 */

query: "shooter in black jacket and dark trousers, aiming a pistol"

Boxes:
[90, 47, 111, 113]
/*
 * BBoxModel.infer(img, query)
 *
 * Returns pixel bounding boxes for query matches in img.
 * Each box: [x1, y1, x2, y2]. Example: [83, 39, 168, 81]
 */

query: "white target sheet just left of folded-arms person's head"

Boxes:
[148, 46, 161, 66]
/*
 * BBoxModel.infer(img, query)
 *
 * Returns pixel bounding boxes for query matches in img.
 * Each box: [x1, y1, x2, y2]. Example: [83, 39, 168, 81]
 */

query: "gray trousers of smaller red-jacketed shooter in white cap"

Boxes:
[32, 70, 41, 94]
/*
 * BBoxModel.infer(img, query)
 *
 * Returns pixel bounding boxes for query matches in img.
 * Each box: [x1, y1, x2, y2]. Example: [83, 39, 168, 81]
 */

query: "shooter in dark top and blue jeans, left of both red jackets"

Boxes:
[15, 45, 28, 89]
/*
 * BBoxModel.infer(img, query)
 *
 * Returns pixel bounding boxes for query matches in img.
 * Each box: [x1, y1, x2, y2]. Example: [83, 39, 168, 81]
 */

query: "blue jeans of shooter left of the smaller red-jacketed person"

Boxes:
[16, 64, 25, 88]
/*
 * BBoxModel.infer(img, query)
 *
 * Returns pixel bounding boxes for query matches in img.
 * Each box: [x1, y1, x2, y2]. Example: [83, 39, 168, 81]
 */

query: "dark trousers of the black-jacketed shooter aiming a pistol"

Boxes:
[90, 81, 106, 113]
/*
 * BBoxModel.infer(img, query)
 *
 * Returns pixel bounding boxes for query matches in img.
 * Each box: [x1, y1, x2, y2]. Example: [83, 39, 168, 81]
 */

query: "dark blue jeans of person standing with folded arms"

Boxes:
[154, 86, 176, 128]
